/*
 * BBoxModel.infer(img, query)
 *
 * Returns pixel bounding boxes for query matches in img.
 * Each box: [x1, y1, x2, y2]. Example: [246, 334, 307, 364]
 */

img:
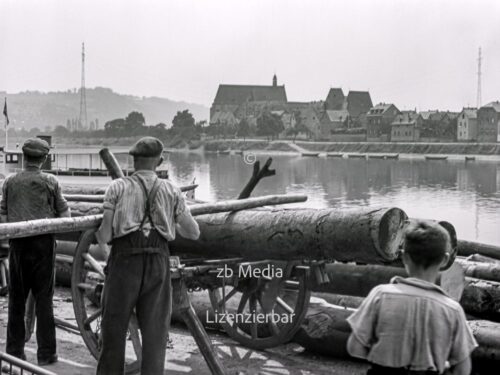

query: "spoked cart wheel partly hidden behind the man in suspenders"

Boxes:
[71, 230, 142, 374]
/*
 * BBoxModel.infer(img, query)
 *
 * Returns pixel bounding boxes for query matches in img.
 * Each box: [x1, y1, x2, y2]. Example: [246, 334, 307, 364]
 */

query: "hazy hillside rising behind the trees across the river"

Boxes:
[0, 87, 209, 129]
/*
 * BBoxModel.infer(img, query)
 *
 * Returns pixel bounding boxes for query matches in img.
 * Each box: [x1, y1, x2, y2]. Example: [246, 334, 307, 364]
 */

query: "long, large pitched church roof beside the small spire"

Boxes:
[214, 85, 287, 105]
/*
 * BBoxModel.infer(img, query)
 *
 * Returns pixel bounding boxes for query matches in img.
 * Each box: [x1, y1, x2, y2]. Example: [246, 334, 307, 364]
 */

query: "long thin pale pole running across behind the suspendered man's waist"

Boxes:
[0, 195, 307, 239]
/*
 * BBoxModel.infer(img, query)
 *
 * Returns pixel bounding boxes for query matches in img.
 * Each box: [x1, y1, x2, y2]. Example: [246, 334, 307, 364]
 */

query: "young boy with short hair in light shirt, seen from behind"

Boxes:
[347, 220, 477, 375]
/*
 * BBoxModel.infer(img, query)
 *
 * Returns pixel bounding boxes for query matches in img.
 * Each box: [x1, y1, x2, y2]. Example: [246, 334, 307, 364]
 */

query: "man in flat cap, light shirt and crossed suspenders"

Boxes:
[96, 137, 200, 375]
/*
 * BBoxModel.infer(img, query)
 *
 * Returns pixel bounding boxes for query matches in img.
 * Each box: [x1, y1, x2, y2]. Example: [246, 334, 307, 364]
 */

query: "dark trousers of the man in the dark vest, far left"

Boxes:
[6, 235, 56, 359]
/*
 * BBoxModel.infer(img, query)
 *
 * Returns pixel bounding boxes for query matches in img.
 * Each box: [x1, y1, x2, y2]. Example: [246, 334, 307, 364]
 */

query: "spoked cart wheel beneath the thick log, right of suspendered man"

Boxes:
[209, 261, 310, 349]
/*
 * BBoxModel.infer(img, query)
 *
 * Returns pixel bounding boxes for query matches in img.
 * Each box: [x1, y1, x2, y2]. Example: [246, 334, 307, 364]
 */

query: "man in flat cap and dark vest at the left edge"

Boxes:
[0, 138, 70, 365]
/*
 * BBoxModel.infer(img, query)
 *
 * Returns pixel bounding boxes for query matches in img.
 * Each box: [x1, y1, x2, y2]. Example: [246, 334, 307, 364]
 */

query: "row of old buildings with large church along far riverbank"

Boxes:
[210, 75, 500, 142]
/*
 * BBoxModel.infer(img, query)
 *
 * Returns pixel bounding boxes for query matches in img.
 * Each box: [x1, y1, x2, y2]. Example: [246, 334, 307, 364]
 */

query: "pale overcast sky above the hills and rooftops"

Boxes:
[0, 0, 500, 110]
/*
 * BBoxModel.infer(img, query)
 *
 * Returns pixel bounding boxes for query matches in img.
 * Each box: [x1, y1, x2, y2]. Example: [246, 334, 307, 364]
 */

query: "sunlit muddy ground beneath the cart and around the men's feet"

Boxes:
[0, 288, 367, 375]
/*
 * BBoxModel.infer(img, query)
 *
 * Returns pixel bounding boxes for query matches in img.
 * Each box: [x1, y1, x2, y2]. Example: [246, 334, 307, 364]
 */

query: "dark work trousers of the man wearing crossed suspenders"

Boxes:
[97, 230, 172, 375]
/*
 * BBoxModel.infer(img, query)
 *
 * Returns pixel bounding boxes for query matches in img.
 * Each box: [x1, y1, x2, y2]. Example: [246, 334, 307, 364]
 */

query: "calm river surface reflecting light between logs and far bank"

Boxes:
[46, 153, 500, 245]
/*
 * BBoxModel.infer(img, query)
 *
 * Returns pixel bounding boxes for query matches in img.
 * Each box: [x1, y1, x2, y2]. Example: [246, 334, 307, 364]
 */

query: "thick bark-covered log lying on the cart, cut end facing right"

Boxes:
[171, 208, 407, 263]
